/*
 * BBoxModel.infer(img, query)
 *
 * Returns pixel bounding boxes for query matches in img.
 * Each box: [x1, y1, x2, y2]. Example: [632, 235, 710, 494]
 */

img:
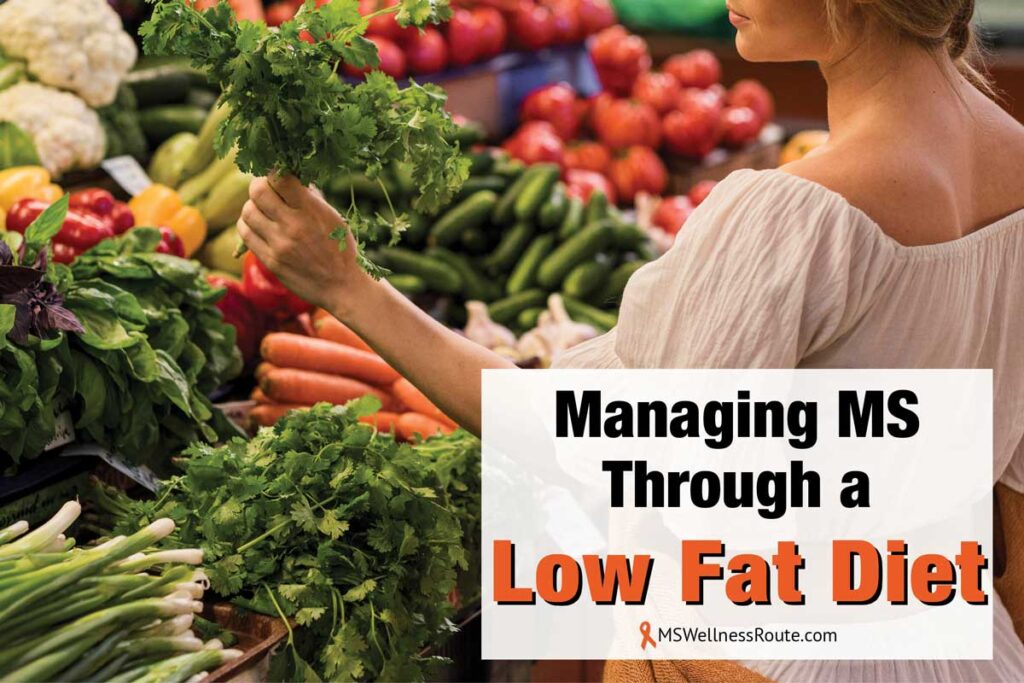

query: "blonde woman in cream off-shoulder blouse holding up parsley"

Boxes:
[240, 0, 1024, 681]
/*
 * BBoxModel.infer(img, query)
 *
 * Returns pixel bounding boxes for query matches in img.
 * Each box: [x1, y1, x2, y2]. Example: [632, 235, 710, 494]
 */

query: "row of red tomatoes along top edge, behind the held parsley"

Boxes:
[266, 0, 615, 79]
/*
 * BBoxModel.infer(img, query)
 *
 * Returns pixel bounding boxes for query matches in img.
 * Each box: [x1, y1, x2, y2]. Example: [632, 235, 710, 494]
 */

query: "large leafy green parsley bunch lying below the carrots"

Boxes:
[100, 397, 480, 681]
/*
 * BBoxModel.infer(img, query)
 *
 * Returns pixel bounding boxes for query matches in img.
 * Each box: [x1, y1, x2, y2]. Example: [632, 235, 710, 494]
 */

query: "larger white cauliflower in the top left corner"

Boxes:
[0, 0, 138, 106]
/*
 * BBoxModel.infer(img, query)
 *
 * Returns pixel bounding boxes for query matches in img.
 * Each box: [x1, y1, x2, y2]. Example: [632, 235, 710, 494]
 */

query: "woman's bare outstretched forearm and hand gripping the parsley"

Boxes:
[239, 177, 514, 434]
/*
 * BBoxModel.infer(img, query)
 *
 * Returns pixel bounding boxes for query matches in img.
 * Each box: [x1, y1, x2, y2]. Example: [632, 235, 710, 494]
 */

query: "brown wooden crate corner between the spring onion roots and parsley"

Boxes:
[203, 603, 288, 683]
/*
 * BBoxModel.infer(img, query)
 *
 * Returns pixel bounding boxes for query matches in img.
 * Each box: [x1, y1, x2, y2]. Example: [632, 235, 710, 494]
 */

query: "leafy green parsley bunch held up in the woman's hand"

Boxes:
[139, 0, 469, 272]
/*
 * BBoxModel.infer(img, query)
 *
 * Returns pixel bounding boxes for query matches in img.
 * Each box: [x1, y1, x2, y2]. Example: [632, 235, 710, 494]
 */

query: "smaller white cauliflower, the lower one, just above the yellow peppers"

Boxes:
[0, 83, 106, 177]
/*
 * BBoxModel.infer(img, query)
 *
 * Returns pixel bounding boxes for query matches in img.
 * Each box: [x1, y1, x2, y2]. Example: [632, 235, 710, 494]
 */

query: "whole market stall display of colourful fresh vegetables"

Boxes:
[0, 0, 821, 681]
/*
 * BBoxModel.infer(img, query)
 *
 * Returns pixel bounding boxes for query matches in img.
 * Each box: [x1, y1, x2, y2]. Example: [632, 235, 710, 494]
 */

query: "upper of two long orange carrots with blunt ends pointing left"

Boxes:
[260, 332, 398, 385]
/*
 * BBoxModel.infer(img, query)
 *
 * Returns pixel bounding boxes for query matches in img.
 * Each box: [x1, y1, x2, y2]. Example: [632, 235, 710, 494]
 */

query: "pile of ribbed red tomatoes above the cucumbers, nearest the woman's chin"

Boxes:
[504, 26, 775, 205]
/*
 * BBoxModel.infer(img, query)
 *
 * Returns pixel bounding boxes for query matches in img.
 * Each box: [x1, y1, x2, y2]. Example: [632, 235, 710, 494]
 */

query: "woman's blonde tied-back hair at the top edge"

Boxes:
[825, 0, 994, 96]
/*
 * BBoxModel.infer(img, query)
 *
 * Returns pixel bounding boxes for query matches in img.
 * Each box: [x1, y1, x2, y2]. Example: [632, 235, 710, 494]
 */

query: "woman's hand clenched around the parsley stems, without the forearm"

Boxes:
[239, 176, 373, 315]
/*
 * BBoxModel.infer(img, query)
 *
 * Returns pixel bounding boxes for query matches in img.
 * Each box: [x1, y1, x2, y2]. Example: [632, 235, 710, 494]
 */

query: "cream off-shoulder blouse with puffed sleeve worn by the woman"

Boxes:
[555, 170, 1024, 682]
